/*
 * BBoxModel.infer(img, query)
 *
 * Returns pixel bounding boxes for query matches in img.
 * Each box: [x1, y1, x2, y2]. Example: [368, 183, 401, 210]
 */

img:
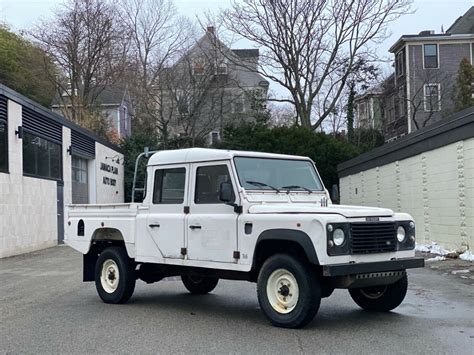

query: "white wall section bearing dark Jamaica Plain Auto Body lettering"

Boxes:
[95, 142, 124, 203]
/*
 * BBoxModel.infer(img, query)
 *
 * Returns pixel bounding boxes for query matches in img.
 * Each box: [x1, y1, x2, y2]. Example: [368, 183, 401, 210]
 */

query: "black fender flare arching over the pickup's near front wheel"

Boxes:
[252, 228, 319, 265]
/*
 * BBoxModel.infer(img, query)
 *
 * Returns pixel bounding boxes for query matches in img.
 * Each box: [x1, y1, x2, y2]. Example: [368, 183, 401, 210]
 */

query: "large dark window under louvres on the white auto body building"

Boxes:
[23, 132, 62, 180]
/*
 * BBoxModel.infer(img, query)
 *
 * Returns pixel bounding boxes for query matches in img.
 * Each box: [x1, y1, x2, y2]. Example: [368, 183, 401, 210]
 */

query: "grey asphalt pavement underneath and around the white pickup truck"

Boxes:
[0, 246, 474, 354]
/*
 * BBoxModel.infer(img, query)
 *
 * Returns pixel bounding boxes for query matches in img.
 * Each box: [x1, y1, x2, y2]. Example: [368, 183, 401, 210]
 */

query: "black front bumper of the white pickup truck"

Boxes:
[322, 258, 425, 277]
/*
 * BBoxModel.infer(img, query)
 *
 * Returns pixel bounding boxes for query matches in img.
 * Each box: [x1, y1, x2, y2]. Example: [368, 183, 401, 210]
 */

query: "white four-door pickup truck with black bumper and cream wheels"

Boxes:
[65, 148, 424, 328]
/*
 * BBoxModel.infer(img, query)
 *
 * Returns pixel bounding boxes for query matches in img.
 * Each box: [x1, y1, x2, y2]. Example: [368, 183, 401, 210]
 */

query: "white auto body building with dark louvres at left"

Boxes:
[0, 84, 124, 257]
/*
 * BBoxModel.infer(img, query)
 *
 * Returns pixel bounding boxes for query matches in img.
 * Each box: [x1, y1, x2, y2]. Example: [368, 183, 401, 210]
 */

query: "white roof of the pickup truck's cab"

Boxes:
[148, 148, 309, 165]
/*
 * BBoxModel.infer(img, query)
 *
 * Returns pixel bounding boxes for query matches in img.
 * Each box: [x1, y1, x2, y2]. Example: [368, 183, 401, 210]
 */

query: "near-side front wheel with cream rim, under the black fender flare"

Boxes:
[257, 254, 321, 328]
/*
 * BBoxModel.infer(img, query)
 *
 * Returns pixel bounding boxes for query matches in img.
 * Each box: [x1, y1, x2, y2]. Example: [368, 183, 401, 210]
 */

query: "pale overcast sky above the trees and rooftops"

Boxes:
[0, 0, 474, 96]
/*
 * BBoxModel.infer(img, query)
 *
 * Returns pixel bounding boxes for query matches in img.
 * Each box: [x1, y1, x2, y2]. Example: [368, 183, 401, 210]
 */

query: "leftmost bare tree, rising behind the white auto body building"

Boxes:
[30, 0, 128, 126]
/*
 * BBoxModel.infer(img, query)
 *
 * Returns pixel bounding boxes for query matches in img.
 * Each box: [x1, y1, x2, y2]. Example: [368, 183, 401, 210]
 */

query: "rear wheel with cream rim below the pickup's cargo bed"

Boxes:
[95, 247, 136, 304]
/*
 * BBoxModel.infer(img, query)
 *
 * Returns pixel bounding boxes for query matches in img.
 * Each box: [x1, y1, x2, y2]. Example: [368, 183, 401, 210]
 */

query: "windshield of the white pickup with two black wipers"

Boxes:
[234, 157, 323, 191]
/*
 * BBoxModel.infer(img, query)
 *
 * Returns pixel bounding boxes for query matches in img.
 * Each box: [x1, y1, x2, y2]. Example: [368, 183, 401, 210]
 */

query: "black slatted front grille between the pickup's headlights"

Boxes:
[351, 222, 397, 254]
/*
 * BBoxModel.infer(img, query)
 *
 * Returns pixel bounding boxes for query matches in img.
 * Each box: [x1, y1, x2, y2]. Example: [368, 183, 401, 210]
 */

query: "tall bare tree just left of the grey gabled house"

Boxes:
[119, 0, 194, 136]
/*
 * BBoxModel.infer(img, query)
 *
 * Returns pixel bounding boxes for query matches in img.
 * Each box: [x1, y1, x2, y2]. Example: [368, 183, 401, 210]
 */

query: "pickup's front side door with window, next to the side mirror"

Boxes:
[186, 161, 238, 262]
